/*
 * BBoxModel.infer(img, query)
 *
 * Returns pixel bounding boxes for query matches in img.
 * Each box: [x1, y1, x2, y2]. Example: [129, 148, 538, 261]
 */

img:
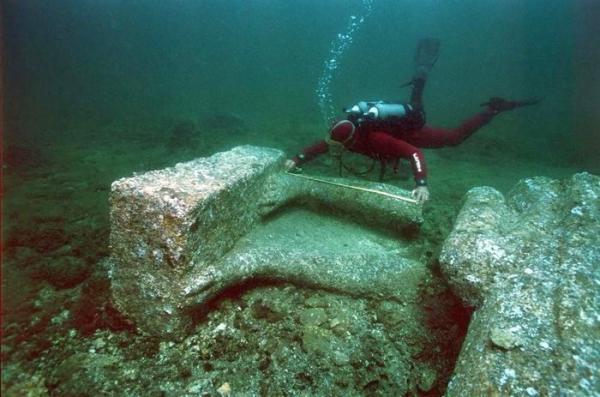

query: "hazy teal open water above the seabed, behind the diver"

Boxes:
[3, 0, 597, 164]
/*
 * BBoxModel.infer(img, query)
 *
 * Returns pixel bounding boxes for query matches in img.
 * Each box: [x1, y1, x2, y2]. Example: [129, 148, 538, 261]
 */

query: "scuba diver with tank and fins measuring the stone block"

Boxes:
[285, 38, 539, 204]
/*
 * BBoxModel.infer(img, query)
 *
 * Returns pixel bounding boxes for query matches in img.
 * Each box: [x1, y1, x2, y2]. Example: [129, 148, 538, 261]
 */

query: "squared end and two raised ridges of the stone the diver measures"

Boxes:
[110, 146, 422, 337]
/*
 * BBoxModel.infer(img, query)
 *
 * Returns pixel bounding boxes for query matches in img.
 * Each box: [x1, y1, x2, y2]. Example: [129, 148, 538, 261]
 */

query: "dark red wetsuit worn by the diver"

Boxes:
[293, 111, 494, 186]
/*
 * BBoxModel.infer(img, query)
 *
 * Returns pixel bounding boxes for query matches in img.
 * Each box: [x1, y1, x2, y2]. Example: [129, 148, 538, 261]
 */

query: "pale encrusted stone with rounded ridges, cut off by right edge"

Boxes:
[440, 173, 600, 396]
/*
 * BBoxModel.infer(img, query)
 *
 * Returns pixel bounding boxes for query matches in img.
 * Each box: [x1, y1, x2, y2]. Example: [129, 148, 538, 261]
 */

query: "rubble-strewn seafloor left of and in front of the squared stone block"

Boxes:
[2, 119, 596, 396]
